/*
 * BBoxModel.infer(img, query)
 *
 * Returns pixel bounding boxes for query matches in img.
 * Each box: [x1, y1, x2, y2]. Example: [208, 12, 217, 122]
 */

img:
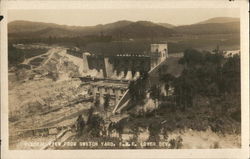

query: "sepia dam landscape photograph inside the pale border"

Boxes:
[5, 8, 244, 150]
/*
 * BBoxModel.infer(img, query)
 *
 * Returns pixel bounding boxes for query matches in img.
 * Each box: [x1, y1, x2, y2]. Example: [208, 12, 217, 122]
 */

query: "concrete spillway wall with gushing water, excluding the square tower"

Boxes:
[83, 54, 151, 80]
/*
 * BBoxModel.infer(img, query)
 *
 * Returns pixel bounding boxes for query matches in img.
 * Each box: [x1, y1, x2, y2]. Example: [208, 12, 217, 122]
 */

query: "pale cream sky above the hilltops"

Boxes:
[8, 8, 240, 26]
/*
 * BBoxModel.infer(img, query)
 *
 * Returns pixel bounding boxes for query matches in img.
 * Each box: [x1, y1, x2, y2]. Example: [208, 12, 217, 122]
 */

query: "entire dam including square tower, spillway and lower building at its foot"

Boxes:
[74, 43, 168, 113]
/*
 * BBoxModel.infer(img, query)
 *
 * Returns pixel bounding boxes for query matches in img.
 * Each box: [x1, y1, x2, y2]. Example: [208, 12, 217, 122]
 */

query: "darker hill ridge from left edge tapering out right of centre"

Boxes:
[8, 21, 174, 38]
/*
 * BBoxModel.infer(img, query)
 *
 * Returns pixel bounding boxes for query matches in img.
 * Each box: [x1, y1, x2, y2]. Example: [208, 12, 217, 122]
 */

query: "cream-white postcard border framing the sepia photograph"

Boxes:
[1, 0, 249, 159]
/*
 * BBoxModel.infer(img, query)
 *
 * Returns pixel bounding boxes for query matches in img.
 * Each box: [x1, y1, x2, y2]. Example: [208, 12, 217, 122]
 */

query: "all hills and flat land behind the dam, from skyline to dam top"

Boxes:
[8, 17, 240, 55]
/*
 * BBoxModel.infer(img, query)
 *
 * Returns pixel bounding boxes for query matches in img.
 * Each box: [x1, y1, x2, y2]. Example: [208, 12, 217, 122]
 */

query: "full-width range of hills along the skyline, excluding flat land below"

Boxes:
[8, 17, 240, 39]
